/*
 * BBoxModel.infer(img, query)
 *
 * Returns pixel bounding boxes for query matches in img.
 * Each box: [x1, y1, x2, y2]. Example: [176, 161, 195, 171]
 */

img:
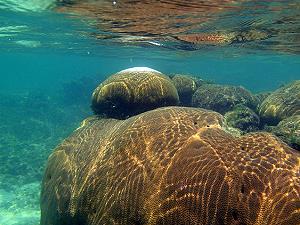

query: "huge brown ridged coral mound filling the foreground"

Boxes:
[41, 107, 300, 225]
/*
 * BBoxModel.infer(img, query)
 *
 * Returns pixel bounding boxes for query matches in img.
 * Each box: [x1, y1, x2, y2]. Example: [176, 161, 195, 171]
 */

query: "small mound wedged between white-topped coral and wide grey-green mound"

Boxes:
[172, 74, 204, 106]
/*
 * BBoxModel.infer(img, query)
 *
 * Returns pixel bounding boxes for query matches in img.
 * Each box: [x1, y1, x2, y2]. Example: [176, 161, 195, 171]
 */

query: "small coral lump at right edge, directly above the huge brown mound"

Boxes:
[271, 115, 300, 150]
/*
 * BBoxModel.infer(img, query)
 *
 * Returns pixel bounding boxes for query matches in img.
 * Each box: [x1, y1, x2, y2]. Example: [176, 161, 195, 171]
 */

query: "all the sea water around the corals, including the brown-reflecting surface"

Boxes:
[0, 0, 300, 225]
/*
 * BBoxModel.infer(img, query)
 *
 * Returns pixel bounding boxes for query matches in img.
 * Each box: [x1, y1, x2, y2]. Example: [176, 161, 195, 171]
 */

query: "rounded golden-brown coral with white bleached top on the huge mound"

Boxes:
[92, 67, 179, 119]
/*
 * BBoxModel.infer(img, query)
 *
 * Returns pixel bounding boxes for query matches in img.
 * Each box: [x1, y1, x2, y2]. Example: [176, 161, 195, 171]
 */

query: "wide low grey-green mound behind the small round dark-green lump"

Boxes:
[192, 84, 258, 114]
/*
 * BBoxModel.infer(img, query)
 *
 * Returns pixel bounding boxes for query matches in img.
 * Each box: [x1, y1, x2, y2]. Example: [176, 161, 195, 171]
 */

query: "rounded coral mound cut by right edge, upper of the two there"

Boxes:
[259, 80, 300, 124]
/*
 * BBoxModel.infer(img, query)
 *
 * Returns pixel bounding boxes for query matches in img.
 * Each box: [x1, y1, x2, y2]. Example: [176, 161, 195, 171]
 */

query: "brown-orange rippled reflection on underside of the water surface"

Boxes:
[56, 0, 300, 53]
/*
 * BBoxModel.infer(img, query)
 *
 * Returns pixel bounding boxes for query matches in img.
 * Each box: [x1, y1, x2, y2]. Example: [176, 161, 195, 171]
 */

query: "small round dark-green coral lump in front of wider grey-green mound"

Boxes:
[224, 105, 260, 133]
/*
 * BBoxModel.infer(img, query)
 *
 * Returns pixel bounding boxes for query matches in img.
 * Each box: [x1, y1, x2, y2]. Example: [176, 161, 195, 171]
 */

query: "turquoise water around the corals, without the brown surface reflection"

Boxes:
[0, 0, 300, 225]
